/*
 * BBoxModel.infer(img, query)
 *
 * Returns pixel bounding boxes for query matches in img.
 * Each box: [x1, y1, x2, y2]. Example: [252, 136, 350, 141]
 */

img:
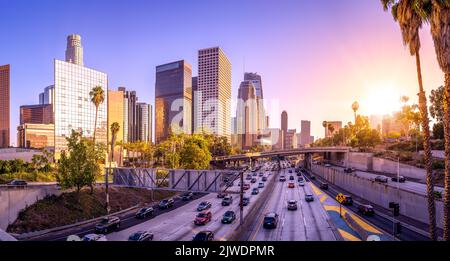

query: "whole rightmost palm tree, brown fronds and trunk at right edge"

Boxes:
[425, 0, 450, 241]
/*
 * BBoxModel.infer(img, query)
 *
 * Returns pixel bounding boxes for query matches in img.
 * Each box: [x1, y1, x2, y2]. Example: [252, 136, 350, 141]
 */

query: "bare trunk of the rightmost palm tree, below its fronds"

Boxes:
[443, 73, 450, 241]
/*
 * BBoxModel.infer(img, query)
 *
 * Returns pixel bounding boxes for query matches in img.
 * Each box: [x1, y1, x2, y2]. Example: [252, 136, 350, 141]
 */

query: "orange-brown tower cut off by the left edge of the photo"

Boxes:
[0, 64, 10, 148]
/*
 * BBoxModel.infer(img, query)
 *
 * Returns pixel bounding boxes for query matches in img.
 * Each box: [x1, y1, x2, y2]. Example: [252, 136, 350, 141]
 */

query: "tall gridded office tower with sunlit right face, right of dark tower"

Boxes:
[196, 47, 231, 138]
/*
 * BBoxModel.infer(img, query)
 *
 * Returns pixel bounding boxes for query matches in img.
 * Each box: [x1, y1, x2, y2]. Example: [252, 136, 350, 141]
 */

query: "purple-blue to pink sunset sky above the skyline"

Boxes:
[0, 0, 443, 144]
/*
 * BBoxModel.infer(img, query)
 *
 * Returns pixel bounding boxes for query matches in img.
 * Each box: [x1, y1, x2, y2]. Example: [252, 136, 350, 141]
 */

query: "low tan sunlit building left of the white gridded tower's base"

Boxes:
[17, 123, 55, 150]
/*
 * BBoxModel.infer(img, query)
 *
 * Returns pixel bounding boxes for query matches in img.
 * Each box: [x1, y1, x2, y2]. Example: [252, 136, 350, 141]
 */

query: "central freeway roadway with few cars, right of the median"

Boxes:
[243, 169, 336, 241]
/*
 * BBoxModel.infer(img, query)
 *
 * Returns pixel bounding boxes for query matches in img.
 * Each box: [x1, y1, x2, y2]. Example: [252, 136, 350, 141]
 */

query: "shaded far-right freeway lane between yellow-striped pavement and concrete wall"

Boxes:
[305, 167, 429, 241]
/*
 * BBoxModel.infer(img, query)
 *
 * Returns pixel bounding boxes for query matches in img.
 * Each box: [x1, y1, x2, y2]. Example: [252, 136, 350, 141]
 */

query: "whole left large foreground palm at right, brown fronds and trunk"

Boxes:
[381, 0, 437, 240]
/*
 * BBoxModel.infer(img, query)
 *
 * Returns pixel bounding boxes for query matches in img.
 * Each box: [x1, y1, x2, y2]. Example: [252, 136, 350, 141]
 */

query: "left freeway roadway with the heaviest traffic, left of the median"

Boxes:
[106, 161, 274, 241]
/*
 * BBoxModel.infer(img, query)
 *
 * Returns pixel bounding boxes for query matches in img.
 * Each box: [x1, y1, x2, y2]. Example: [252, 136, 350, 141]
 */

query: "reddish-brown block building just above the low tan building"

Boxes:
[20, 104, 54, 124]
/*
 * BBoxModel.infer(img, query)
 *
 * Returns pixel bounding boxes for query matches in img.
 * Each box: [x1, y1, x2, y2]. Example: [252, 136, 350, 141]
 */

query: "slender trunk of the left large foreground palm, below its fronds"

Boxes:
[416, 51, 437, 241]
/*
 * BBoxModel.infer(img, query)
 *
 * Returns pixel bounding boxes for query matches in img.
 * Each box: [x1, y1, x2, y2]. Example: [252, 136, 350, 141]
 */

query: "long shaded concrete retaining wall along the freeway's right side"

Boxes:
[312, 165, 444, 228]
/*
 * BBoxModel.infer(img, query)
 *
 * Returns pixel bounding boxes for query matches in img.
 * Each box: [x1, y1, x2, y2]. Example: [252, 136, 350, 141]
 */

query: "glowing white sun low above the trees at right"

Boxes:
[359, 86, 401, 115]
